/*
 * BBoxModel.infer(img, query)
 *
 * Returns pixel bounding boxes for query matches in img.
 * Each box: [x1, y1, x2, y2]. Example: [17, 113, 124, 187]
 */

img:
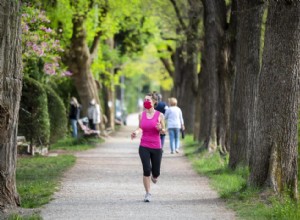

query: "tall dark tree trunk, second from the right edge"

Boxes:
[229, 0, 263, 169]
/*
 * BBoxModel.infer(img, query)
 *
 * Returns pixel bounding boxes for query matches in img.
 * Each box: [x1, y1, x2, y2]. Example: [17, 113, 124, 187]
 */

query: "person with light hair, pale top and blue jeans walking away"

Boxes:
[165, 97, 185, 154]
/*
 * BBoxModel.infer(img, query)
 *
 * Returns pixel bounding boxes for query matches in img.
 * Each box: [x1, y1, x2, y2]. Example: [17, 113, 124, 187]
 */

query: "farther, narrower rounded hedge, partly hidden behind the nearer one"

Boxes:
[44, 86, 68, 143]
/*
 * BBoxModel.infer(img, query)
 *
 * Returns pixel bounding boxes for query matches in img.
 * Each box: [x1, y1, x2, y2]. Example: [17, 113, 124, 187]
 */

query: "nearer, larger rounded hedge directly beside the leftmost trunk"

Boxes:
[18, 77, 50, 146]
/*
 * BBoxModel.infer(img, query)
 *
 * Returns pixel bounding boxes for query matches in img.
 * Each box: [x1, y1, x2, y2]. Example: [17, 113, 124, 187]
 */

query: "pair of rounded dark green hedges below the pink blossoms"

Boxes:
[18, 77, 68, 146]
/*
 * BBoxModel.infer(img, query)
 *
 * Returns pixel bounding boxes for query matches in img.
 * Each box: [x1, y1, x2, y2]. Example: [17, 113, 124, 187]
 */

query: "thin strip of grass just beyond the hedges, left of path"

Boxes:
[49, 137, 103, 152]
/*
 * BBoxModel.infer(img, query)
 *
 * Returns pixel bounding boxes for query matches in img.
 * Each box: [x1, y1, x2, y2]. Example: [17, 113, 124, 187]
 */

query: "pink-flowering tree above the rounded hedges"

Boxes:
[22, 5, 71, 79]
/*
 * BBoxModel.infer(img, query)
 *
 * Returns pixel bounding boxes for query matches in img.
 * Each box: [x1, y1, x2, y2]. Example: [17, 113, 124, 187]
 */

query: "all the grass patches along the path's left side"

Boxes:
[9, 138, 103, 220]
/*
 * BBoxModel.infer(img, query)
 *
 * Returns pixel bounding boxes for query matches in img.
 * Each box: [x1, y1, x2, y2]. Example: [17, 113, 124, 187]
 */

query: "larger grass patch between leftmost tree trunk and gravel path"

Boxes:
[16, 155, 76, 208]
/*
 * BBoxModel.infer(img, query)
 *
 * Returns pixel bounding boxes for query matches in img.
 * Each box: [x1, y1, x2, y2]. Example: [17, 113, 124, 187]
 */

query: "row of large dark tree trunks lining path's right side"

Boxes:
[164, 0, 300, 198]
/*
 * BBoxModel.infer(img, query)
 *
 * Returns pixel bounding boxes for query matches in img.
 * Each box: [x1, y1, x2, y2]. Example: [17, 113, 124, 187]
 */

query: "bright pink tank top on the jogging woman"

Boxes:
[140, 111, 161, 149]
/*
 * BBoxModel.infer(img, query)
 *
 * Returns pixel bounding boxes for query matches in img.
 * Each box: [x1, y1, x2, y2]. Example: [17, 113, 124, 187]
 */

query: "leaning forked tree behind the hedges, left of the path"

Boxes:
[65, 1, 108, 116]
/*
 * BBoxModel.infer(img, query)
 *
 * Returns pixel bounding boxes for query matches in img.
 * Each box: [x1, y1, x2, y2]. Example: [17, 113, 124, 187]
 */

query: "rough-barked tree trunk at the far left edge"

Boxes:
[0, 0, 22, 210]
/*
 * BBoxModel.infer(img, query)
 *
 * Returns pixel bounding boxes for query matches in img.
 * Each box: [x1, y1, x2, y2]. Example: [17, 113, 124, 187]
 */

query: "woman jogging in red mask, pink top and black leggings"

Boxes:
[131, 93, 165, 202]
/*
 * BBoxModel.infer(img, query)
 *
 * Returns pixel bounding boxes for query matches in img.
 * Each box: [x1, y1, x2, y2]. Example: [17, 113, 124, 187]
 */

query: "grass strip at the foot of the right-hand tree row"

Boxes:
[184, 135, 300, 220]
